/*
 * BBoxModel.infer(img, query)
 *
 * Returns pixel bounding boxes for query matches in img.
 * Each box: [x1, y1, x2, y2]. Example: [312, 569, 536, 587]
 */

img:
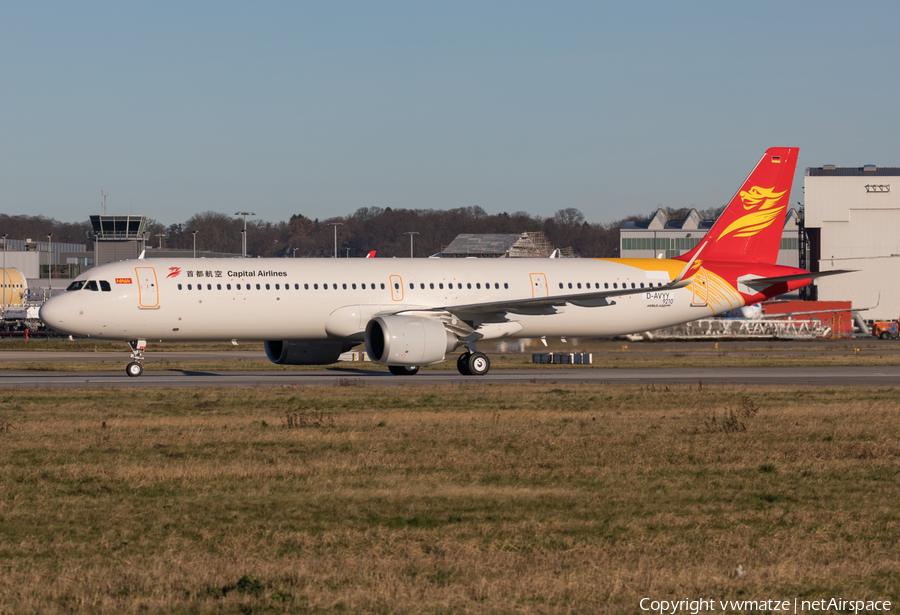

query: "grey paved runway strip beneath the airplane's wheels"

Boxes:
[0, 366, 900, 389]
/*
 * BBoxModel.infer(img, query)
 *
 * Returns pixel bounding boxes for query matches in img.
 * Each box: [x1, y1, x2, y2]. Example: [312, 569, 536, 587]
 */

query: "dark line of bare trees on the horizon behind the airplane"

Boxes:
[0, 205, 722, 258]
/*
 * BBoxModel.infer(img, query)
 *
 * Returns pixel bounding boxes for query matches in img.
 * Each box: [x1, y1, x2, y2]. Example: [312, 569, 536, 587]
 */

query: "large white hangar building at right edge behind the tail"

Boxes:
[804, 165, 900, 320]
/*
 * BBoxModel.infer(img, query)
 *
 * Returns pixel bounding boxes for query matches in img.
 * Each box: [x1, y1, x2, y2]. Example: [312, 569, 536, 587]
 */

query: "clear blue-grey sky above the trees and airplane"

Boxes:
[0, 0, 900, 230]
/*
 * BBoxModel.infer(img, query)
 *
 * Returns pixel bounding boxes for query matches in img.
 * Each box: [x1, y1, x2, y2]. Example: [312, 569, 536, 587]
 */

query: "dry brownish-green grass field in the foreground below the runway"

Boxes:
[0, 388, 900, 613]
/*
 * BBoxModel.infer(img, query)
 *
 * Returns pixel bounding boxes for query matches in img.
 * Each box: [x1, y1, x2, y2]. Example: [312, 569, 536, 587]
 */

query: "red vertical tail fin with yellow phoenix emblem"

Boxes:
[677, 147, 799, 264]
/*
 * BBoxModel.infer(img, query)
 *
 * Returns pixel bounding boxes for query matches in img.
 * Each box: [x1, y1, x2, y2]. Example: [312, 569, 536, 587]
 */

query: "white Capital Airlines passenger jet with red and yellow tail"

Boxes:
[40, 147, 845, 376]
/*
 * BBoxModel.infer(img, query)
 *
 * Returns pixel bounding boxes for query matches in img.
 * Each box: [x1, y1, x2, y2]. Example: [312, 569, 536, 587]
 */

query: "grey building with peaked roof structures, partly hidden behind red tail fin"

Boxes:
[619, 208, 800, 267]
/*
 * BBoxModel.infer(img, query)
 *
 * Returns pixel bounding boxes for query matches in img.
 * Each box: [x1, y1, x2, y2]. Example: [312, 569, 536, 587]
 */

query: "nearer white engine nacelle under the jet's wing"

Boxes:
[366, 316, 459, 365]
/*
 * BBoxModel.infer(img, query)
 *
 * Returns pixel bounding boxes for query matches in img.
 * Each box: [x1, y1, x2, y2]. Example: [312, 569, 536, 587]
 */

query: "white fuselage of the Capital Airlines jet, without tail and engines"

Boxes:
[41, 258, 743, 341]
